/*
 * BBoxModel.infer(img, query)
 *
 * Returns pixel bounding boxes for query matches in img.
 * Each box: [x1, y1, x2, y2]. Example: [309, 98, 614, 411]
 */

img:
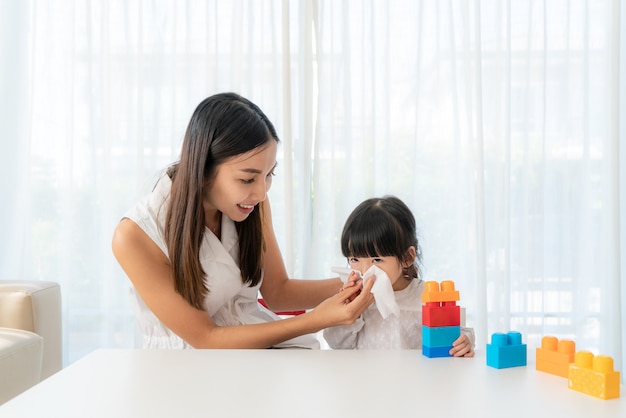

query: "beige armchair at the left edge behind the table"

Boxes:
[0, 280, 63, 404]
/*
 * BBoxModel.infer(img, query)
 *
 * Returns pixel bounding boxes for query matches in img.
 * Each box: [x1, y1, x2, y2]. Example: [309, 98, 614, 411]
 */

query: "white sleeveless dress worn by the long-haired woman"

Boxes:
[125, 174, 320, 349]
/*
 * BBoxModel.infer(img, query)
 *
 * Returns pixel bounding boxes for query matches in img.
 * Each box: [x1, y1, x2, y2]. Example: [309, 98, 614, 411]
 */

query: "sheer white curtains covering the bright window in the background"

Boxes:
[0, 0, 626, 369]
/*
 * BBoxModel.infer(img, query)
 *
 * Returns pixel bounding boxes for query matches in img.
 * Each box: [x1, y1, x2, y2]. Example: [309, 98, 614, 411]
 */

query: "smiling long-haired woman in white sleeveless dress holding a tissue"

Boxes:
[112, 93, 373, 348]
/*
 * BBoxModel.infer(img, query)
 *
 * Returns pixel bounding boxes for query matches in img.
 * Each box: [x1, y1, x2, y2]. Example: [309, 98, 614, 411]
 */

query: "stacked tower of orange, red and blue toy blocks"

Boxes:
[422, 280, 461, 358]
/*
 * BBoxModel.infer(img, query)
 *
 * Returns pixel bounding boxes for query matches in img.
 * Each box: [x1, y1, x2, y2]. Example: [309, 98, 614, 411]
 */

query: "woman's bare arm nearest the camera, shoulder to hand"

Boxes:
[112, 219, 373, 348]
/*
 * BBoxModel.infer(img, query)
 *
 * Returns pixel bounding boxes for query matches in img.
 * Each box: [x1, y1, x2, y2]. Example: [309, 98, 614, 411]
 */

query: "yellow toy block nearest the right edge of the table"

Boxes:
[567, 351, 620, 399]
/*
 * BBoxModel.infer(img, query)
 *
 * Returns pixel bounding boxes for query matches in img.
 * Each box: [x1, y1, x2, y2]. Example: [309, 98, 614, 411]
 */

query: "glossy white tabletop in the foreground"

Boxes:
[0, 350, 626, 418]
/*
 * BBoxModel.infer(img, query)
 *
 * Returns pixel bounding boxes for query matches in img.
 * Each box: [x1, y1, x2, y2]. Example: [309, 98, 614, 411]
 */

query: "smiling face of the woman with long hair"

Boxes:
[203, 139, 278, 222]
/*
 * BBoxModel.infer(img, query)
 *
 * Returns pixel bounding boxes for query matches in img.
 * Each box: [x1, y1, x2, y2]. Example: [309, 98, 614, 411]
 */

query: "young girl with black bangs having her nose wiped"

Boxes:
[324, 196, 474, 357]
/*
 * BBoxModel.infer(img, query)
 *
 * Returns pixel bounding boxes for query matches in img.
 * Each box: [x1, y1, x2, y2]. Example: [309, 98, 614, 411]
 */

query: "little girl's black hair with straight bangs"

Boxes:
[341, 195, 422, 279]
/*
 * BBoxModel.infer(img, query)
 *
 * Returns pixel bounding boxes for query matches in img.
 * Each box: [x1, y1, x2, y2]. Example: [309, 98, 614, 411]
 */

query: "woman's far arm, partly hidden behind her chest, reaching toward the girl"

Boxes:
[261, 200, 343, 311]
